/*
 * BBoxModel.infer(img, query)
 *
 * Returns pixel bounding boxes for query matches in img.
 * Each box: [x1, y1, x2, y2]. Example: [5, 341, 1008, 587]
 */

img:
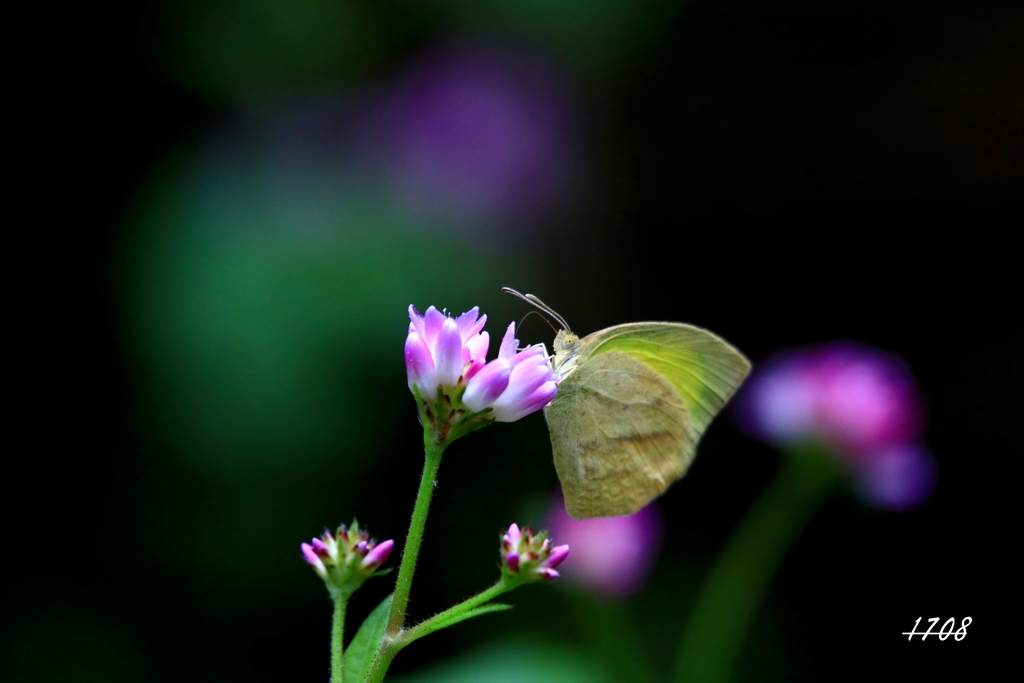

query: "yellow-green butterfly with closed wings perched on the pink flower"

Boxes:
[502, 287, 751, 519]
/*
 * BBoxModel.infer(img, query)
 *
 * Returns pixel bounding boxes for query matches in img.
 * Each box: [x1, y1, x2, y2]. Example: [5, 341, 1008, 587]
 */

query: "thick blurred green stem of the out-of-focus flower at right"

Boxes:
[674, 451, 839, 683]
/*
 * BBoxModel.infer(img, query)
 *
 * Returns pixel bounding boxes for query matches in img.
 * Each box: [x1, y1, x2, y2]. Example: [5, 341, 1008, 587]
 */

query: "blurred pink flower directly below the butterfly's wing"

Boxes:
[547, 496, 664, 596]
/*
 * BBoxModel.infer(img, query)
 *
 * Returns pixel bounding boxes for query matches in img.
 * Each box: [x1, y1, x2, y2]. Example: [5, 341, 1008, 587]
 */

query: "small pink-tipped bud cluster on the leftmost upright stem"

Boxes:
[301, 520, 394, 595]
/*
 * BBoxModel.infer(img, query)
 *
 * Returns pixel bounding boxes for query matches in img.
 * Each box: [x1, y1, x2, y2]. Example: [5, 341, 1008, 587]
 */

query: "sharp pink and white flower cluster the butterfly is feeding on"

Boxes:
[406, 306, 559, 422]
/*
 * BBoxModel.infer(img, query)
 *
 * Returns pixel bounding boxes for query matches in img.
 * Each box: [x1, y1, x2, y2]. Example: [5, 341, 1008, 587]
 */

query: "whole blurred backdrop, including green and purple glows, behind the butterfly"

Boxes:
[6, 0, 1024, 683]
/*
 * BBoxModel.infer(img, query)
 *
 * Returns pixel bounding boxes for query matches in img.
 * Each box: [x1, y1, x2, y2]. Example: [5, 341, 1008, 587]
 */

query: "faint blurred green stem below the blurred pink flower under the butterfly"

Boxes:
[568, 593, 657, 683]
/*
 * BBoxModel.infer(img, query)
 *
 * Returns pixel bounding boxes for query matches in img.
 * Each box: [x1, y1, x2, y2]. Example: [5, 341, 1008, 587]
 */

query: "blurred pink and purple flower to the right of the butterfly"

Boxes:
[734, 342, 936, 509]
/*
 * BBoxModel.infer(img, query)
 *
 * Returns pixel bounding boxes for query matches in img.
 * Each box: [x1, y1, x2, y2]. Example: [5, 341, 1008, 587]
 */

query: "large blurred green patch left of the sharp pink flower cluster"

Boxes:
[123, 137, 540, 611]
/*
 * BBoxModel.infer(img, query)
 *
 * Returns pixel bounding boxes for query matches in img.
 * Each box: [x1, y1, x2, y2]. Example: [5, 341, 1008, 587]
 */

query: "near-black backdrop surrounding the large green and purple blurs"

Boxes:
[2, 0, 1024, 681]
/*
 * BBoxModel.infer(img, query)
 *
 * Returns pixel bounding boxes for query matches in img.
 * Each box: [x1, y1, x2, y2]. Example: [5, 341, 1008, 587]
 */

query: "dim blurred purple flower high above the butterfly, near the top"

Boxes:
[370, 48, 569, 224]
